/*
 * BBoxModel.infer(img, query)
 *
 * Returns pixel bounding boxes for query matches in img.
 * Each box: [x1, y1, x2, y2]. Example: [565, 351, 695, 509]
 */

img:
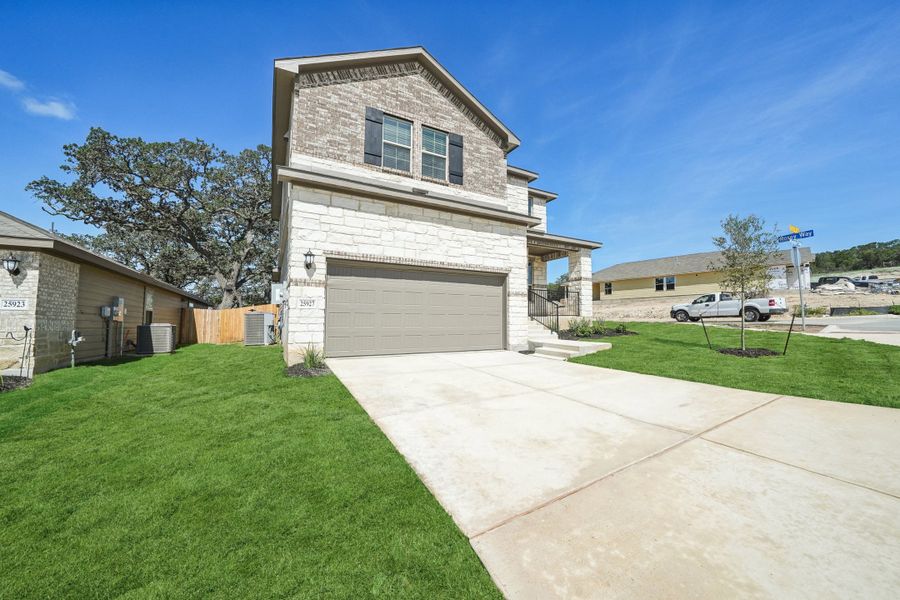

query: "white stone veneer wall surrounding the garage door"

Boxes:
[283, 185, 528, 364]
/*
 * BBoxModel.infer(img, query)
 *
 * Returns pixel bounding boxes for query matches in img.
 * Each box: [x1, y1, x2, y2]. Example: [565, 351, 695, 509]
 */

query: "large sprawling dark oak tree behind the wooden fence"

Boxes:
[27, 128, 278, 308]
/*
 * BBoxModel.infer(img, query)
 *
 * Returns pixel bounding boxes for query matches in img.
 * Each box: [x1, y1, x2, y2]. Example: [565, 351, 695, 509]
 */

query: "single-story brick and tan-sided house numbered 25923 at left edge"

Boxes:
[0, 212, 206, 377]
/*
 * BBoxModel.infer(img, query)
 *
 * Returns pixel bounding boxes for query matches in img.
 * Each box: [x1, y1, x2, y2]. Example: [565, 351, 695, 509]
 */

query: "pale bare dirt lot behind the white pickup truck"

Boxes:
[594, 291, 900, 321]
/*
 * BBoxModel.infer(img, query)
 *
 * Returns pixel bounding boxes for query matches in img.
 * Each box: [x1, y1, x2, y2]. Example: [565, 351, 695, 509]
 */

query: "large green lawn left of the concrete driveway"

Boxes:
[0, 346, 500, 598]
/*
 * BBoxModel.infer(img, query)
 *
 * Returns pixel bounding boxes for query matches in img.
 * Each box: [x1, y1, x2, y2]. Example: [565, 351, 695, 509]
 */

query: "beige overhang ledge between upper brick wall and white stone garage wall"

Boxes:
[277, 166, 541, 227]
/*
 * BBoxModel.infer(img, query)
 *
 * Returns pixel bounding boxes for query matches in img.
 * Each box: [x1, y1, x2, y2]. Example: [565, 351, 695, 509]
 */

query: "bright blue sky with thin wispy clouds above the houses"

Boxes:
[0, 1, 900, 282]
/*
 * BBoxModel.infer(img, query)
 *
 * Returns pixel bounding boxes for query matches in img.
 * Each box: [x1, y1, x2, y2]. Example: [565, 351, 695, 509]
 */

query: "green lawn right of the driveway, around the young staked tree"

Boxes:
[571, 323, 900, 408]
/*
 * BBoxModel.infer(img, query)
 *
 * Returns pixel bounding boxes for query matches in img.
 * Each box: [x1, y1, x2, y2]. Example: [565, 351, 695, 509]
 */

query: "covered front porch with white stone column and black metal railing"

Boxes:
[527, 231, 600, 332]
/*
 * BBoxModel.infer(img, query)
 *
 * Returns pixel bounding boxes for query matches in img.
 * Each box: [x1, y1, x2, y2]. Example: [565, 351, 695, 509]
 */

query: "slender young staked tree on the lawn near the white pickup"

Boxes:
[710, 215, 778, 350]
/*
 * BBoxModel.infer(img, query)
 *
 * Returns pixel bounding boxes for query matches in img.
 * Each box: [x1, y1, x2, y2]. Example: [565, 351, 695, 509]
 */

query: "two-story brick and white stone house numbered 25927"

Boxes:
[272, 47, 600, 363]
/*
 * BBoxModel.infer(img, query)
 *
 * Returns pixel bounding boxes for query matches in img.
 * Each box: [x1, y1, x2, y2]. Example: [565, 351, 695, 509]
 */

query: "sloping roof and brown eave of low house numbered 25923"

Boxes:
[0, 211, 208, 306]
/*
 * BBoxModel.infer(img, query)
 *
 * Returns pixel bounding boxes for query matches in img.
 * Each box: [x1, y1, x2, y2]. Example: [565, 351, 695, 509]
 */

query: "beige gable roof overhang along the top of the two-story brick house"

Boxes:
[272, 46, 521, 218]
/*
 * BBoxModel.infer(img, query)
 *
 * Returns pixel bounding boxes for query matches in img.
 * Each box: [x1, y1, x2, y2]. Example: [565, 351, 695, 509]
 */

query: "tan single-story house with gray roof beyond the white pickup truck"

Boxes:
[594, 248, 815, 301]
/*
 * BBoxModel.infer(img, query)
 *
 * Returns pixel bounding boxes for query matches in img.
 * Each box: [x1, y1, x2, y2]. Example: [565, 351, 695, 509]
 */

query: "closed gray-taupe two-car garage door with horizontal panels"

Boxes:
[325, 262, 504, 356]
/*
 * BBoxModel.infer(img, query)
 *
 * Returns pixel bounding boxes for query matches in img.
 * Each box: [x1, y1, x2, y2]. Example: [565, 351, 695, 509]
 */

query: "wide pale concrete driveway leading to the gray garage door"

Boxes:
[328, 352, 900, 599]
